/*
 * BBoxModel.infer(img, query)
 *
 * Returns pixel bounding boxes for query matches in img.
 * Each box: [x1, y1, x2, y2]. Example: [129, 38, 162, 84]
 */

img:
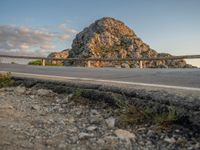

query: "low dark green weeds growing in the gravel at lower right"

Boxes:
[119, 105, 179, 128]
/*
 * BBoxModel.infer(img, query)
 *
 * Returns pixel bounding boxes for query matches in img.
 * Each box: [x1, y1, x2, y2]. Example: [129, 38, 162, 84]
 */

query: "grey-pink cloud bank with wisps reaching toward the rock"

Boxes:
[0, 25, 76, 54]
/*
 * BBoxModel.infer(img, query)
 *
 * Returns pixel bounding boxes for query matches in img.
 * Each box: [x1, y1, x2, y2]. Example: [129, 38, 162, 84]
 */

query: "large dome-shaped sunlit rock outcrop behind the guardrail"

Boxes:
[69, 17, 191, 68]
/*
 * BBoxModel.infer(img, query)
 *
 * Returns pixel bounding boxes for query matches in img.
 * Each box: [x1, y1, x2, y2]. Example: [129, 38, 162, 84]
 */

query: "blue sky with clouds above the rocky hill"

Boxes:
[0, 0, 200, 66]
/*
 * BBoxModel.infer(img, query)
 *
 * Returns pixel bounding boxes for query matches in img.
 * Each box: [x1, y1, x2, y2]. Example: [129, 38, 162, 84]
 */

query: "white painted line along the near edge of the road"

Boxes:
[0, 71, 200, 91]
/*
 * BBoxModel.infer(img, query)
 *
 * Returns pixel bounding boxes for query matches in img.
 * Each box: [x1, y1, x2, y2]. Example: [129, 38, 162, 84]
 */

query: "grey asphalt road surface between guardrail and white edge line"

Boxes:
[0, 64, 200, 90]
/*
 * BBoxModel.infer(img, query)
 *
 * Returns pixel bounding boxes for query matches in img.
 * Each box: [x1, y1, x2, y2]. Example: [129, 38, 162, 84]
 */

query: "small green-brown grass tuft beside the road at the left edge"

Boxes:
[0, 73, 14, 88]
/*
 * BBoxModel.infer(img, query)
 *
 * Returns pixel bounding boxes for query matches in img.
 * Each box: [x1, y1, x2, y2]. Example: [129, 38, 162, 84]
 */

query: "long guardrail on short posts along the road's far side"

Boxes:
[0, 55, 200, 68]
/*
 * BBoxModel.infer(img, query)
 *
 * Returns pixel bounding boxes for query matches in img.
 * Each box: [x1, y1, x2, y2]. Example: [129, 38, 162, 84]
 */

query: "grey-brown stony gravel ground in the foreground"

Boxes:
[0, 86, 200, 150]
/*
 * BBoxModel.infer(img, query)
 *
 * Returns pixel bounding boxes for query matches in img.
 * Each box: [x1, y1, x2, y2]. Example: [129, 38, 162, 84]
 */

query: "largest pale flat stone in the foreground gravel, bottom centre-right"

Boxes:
[115, 129, 136, 140]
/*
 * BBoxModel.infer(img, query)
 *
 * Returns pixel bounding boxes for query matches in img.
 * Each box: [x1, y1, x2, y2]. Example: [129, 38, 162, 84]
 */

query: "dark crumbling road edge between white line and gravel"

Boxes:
[8, 75, 200, 131]
